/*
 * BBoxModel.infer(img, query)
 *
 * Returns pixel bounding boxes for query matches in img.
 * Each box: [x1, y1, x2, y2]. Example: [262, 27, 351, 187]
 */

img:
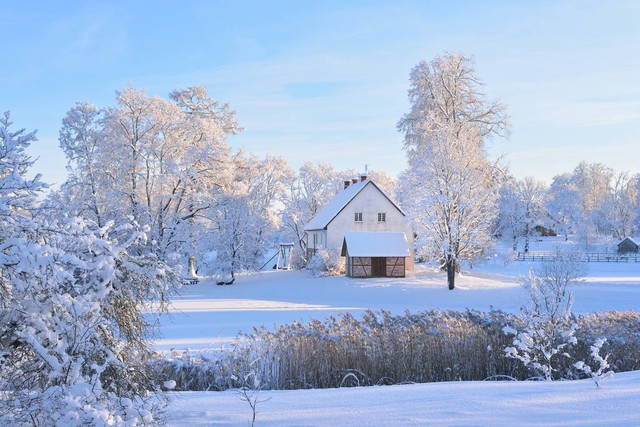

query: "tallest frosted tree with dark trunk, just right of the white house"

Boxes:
[398, 53, 508, 289]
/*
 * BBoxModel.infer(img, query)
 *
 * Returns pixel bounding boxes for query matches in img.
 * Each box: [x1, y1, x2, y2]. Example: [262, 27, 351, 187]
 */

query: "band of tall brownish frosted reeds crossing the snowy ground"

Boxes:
[154, 311, 640, 390]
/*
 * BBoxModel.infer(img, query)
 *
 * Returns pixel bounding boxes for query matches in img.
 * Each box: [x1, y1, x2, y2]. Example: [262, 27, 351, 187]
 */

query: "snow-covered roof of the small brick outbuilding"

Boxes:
[342, 231, 411, 257]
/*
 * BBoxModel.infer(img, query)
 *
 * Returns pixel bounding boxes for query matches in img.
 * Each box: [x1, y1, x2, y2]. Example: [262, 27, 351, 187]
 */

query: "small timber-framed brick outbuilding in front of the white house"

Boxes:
[342, 232, 413, 277]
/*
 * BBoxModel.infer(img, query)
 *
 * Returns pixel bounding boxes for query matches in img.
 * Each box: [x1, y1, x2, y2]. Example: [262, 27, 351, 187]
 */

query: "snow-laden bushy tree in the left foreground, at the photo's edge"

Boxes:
[0, 114, 177, 425]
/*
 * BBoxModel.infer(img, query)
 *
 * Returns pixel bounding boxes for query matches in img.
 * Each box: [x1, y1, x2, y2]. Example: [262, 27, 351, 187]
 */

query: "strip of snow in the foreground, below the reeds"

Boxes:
[169, 372, 640, 426]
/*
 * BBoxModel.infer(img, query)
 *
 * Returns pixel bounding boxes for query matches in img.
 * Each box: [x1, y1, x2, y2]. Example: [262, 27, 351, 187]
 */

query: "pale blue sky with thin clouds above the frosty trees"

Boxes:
[0, 0, 640, 183]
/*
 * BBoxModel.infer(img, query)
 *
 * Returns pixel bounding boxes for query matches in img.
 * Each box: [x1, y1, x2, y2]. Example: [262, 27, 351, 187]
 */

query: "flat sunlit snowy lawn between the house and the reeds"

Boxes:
[155, 262, 640, 350]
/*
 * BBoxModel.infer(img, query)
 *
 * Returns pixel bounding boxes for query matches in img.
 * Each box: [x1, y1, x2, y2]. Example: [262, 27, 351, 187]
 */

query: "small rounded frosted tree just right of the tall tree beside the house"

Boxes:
[498, 177, 547, 252]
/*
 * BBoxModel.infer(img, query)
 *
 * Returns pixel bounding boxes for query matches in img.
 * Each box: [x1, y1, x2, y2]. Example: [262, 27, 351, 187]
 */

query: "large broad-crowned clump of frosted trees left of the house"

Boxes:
[60, 86, 239, 262]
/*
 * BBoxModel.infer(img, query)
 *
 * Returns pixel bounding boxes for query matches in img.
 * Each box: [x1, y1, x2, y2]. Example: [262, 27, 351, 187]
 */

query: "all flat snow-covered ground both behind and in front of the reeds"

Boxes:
[155, 249, 640, 426]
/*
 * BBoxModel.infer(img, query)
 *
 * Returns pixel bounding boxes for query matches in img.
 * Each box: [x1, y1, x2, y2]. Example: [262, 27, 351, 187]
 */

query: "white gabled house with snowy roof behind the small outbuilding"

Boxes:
[304, 175, 413, 276]
